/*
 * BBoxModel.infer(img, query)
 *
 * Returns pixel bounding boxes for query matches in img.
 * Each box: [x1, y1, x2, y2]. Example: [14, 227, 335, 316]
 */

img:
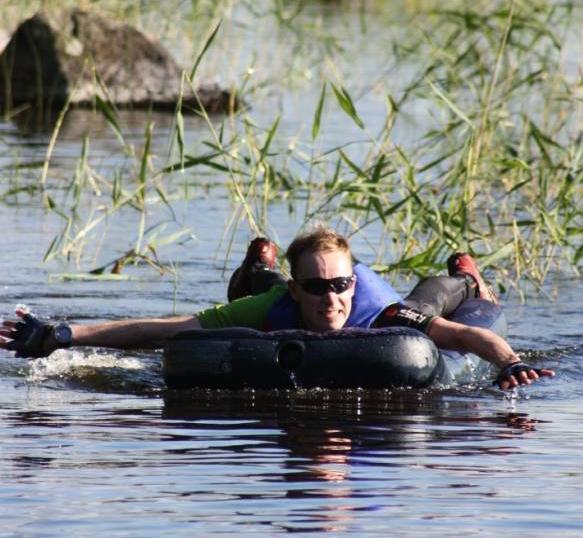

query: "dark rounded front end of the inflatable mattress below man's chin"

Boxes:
[164, 327, 443, 389]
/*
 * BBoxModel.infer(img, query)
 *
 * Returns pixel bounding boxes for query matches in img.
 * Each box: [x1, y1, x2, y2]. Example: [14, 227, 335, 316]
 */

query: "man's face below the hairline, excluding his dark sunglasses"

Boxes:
[288, 250, 354, 332]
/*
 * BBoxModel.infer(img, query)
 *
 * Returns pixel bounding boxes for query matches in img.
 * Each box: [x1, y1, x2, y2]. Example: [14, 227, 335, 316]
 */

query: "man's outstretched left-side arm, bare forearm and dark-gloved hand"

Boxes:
[0, 310, 201, 357]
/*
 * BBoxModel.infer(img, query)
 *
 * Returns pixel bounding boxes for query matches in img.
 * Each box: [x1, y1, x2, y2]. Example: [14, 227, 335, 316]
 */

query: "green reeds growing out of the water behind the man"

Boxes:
[0, 0, 583, 294]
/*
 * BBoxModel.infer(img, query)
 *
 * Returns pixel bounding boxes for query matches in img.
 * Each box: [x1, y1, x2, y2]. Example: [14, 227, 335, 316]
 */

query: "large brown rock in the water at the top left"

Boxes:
[0, 9, 237, 112]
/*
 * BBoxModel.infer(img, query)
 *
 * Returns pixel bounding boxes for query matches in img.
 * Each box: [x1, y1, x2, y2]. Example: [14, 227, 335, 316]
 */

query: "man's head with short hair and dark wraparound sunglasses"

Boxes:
[286, 228, 355, 332]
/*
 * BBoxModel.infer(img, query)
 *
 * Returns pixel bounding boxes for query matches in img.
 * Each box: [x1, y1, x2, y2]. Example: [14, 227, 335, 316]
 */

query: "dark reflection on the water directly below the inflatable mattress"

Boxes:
[162, 391, 539, 472]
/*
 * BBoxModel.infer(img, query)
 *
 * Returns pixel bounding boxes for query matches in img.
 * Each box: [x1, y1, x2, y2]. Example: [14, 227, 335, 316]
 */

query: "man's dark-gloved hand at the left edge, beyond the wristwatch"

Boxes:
[0, 309, 58, 358]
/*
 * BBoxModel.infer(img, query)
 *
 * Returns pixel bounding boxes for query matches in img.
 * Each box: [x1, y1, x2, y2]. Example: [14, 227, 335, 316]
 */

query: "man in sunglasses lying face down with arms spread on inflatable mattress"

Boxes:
[0, 227, 554, 390]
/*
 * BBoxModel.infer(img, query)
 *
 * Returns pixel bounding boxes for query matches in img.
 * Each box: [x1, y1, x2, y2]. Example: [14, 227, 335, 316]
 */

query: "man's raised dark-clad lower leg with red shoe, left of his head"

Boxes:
[227, 237, 286, 302]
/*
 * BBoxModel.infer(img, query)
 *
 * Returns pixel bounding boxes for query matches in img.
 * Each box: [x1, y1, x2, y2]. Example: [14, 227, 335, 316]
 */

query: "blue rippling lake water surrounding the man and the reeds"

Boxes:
[0, 2, 583, 537]
